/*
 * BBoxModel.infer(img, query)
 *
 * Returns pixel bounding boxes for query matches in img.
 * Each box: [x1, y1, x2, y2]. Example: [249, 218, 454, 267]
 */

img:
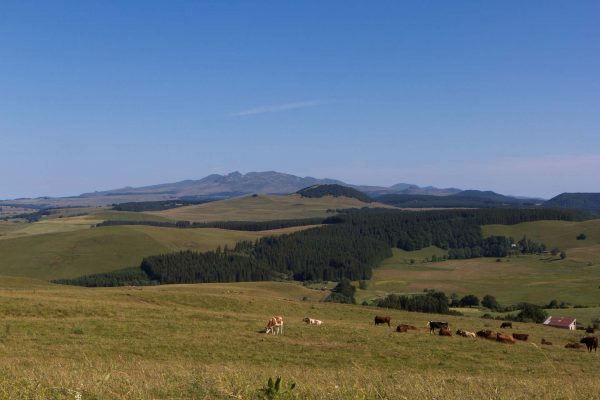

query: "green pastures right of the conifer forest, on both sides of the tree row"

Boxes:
[359, 219, 600, 308]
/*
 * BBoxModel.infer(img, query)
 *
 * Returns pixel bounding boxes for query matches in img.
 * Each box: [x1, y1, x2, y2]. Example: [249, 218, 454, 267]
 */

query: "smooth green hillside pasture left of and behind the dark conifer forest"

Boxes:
[0, 225, 310, 280]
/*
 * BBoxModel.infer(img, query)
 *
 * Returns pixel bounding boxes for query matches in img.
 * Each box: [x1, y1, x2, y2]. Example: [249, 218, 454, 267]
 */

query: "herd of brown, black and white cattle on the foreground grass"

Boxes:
[265, 315, 598, 353]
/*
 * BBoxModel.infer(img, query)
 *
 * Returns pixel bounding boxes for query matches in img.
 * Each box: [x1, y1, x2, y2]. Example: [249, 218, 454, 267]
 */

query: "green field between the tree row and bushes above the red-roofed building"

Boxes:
[365, 249, 600, 306]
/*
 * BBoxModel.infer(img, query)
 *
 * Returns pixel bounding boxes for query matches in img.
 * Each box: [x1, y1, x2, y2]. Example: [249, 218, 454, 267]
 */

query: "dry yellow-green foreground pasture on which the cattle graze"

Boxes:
[0, 278, 600, 399]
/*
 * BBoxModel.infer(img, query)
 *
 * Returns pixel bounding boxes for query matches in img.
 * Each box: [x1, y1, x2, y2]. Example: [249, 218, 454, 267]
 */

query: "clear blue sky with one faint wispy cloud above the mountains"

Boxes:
[0, 0, 600, 198]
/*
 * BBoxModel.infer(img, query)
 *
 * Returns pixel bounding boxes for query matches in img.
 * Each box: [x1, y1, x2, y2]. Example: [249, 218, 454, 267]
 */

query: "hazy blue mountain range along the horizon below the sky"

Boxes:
[0, 171, 600, 212]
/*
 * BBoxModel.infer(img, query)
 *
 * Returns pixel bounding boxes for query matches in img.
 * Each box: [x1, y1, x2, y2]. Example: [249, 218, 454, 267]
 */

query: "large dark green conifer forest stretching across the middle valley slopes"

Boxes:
[56, 209, 585, 286]
